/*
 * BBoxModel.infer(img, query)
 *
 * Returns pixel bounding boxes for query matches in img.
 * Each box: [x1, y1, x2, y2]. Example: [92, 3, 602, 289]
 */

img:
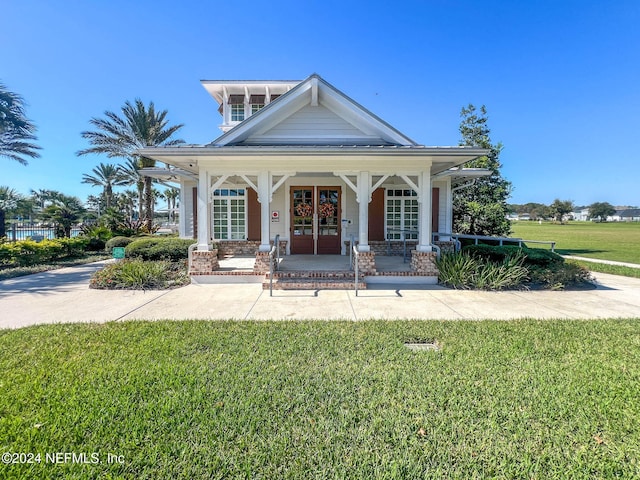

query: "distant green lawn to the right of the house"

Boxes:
[511, 222, 640, 264]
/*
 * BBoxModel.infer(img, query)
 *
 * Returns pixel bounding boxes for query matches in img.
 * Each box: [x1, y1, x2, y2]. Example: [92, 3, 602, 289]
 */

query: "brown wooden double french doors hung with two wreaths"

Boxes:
[291, 187, 342, 255]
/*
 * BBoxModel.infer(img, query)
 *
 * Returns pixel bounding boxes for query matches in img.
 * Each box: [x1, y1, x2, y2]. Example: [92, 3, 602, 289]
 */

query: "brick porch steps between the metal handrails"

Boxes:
[262, 271, 367, 290]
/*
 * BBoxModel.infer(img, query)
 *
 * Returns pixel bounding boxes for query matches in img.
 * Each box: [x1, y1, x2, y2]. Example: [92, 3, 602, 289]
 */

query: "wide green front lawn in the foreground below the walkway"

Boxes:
[0, 319, 640, 479]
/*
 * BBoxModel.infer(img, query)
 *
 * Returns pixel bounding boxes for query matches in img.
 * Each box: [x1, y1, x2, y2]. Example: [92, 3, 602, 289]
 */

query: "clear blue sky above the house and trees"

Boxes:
[5, 0, 640, 205]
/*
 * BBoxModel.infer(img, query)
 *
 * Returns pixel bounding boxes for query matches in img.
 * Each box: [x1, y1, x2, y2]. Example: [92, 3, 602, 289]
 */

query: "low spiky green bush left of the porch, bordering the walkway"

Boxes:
[89, 258, 189, 290]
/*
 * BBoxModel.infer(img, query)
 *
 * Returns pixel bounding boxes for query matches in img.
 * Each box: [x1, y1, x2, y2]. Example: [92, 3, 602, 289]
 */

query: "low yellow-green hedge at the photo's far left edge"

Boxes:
[0, 237, 89, 267]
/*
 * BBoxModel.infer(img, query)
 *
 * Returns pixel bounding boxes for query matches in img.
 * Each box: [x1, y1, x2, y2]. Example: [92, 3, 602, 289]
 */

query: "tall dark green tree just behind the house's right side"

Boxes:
[453, 104, 511, 236]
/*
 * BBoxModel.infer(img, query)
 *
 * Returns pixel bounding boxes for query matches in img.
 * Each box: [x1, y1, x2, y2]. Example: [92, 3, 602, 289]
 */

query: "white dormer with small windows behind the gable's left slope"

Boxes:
[201, 80, 300, 133]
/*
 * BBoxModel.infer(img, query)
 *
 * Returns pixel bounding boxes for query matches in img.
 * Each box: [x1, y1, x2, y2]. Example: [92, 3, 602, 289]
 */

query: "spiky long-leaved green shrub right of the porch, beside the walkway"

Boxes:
[436, 252, 529, 290]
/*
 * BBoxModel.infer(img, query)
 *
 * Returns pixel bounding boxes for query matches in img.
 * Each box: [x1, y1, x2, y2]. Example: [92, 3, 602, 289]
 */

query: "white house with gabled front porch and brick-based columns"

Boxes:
[140, 74, 487, 280]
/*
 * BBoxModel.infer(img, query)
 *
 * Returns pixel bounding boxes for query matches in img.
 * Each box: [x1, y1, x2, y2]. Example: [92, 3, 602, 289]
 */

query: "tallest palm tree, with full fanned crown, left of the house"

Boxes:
[77, 99, 184, 230]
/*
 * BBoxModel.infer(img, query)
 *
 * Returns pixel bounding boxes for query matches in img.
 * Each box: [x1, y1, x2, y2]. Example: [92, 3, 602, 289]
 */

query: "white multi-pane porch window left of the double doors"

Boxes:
[212, 188, 247, 240]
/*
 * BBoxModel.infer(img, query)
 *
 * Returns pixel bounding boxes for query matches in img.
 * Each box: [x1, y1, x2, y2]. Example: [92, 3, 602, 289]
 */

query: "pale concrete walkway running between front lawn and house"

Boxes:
[0, 262, 640, 329]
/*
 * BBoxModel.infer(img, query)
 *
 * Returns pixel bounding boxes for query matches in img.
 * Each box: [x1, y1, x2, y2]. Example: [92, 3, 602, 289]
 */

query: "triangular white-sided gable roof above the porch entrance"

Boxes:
[210, 74, 417, 147]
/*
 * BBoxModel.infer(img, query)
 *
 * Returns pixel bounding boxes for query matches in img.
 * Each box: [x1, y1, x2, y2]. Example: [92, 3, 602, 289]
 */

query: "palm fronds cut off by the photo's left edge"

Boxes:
[0, 83, 40, 165]
